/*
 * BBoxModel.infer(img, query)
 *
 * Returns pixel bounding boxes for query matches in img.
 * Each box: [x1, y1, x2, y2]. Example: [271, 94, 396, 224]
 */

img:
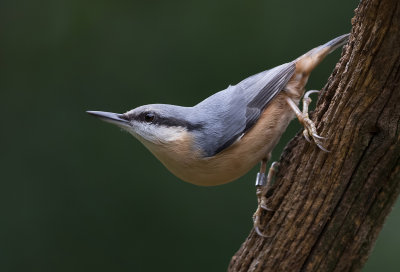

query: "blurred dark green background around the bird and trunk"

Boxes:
[0, 0, 400, 271]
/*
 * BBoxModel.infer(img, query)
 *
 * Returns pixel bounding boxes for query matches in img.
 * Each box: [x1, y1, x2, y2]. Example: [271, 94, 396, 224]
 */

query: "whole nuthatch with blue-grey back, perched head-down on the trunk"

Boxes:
[88, 34, 349, 235]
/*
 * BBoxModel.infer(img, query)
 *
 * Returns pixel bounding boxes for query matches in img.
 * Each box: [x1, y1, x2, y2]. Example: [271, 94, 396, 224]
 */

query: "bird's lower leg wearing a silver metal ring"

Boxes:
[253, 159, 279, 237]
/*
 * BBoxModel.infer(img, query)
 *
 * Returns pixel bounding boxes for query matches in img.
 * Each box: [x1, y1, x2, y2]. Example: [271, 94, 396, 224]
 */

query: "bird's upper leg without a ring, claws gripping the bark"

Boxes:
[286, 90, 329, 152]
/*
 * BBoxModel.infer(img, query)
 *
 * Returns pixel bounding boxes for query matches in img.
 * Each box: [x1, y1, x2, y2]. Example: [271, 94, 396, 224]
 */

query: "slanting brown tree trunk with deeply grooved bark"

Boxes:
[229, 0, 400, 271]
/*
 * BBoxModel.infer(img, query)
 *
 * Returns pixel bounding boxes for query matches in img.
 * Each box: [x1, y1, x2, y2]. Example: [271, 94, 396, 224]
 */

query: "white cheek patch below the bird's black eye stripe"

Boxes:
[128, 121, 187, 143]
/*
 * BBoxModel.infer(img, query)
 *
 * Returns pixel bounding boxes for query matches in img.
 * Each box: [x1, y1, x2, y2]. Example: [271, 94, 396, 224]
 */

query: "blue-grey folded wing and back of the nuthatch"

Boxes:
[193, 62, 295, 157]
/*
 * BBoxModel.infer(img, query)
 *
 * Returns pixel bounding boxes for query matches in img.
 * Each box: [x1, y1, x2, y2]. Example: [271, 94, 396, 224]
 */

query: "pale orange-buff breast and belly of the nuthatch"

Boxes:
[147, 94, 294, 186]
